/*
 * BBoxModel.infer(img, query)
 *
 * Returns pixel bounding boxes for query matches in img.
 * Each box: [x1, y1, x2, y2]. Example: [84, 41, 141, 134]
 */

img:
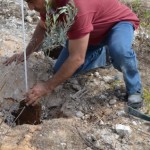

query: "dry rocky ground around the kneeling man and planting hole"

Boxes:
[0, 0, 150, 150]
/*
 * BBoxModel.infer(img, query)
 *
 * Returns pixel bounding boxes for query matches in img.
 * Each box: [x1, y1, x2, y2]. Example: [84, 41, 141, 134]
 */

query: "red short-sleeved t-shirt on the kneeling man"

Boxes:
[41, 0, 139, 45]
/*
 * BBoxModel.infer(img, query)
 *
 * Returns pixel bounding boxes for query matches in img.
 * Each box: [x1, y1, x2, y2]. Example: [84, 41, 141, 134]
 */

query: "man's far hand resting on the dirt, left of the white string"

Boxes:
[3, 53, 24, 66]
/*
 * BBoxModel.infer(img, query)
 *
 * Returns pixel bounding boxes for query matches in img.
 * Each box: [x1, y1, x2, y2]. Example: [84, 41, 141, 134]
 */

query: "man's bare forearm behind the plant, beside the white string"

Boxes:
[26, 22, 46, 56]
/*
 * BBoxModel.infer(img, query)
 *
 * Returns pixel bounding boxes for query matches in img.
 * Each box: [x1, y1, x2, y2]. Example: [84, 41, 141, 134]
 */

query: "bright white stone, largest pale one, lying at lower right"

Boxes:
[115, 124, 132, 137]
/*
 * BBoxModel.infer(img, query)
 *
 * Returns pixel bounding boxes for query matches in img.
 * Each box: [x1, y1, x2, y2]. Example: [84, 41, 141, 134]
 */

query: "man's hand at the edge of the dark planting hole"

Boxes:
[25, 82, 51, 106]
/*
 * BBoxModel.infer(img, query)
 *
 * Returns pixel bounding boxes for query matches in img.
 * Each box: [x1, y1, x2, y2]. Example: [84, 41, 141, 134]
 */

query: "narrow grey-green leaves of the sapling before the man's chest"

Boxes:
[42, 0, 77, 55]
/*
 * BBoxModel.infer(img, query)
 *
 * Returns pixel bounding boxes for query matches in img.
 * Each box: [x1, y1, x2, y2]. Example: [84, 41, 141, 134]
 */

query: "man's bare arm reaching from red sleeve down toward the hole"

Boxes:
[47, 34, 90, 91]
